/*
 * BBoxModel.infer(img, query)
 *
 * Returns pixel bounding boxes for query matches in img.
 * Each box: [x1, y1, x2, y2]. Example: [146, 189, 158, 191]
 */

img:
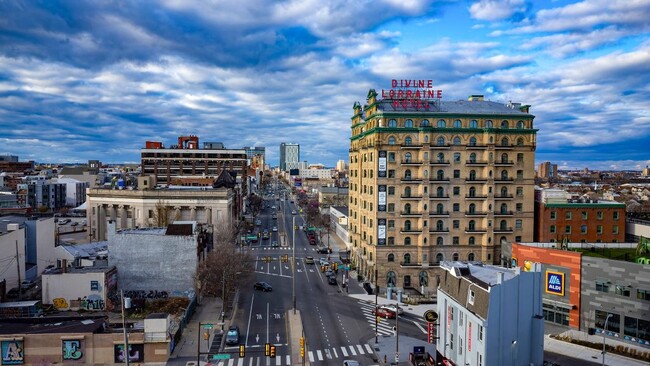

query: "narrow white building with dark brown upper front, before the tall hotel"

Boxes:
[437, 262, 544, 366]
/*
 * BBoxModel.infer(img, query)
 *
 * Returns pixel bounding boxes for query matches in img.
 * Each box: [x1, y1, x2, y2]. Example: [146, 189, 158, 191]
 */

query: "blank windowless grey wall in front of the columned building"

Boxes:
[108, 224, 198, 292]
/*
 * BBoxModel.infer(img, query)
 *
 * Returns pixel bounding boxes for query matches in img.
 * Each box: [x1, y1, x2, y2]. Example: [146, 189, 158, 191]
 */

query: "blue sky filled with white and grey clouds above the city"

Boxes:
[0, 0, 650, 170]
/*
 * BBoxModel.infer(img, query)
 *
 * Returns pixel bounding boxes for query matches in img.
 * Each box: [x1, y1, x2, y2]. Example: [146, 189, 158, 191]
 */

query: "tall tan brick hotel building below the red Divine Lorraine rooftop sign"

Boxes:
[348, 90, 537, 292]
